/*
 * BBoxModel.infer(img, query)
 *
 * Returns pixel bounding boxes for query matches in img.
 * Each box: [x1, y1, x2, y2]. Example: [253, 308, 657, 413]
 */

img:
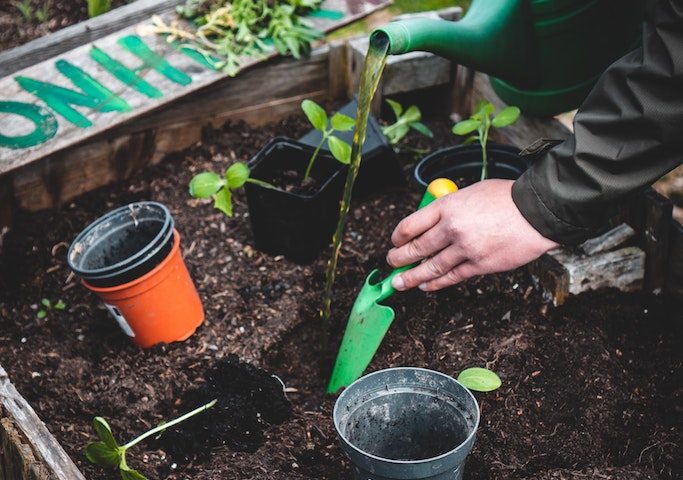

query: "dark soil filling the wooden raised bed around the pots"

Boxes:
[0, 113, 683, 480]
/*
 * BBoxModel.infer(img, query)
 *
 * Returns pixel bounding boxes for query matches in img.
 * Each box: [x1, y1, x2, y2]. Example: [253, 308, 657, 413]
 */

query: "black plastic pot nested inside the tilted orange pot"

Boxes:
[67, 202, 174, 287]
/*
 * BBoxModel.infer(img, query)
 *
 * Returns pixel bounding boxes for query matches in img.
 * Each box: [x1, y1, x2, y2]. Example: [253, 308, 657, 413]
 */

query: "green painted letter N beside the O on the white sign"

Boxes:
[16, 60, 131, 128]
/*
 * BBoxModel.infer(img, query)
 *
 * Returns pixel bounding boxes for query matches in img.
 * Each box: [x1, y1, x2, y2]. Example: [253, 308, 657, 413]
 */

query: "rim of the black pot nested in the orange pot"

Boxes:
[66, 200, 175, 280]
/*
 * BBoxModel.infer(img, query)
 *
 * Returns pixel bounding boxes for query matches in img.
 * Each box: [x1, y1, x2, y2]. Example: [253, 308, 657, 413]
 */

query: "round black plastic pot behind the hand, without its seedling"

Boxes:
[414, 144, 529, 188]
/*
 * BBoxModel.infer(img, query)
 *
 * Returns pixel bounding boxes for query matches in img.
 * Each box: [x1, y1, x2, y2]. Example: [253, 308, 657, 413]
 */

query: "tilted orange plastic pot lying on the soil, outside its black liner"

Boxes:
[83, 230, 204, 348]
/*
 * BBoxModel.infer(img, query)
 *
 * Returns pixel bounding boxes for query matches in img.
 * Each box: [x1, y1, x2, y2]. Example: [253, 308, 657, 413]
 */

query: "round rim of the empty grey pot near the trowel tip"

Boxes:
[332, 367, 481, 466]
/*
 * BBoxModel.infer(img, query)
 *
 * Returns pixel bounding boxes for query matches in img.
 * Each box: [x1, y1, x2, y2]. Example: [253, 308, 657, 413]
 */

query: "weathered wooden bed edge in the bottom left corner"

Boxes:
[0, 366, 85, 480]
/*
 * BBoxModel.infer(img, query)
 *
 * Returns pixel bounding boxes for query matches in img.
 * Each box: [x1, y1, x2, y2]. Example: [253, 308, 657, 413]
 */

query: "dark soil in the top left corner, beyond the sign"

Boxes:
[0, 0, 135, 51]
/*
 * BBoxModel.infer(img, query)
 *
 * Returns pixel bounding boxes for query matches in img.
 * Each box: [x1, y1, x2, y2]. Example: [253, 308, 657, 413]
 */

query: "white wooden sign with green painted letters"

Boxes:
[0, 0, 391, 175]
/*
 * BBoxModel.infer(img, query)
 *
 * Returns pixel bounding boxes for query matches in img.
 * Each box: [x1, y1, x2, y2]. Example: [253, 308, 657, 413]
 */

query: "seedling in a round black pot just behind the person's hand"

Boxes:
[415, 100, 528, 188]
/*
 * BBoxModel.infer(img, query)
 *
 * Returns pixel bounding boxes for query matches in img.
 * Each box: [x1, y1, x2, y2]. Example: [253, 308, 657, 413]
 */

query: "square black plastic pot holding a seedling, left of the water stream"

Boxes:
[245, 137, 346, 263]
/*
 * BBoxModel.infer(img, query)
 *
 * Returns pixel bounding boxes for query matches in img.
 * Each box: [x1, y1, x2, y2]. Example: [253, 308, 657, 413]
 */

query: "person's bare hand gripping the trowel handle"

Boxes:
[387, 180, 558, 291]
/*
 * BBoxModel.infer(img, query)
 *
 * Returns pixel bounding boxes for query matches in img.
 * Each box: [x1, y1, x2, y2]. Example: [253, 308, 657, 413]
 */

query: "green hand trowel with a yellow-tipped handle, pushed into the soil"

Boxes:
[327, 178, 458, 393]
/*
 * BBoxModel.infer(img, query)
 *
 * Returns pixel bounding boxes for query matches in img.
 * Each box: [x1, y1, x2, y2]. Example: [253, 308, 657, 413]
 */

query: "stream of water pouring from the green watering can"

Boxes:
[322, 35, 389, 322]
